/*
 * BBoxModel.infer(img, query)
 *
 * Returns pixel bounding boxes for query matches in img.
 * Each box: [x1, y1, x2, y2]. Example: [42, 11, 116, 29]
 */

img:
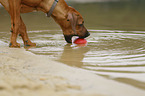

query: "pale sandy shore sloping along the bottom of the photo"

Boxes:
[0, 46, 145, 96]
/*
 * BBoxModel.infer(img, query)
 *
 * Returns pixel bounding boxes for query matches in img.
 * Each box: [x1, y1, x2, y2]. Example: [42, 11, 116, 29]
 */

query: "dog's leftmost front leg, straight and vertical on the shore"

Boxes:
[9, 0, 21, 47]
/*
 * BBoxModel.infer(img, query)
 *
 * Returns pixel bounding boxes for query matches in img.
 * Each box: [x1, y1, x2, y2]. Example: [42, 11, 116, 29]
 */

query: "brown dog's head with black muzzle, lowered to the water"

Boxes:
[53, 7, 90, 43]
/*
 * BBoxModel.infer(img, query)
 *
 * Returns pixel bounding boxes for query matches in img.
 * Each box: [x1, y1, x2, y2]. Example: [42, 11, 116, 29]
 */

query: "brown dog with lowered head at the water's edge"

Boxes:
[0, 0, 90, 47]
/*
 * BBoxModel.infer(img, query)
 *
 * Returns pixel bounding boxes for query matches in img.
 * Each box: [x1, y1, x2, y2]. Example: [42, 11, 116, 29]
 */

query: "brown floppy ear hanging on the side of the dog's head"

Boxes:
[67, 12, 77, 34]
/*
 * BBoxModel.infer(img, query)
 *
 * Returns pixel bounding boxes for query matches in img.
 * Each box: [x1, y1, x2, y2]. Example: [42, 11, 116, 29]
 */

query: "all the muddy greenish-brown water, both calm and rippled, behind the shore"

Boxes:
[0, 0, 145, 90]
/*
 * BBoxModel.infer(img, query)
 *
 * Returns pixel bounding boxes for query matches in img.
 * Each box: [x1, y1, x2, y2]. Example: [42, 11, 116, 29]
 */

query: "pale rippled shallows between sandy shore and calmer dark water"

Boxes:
[0, 30, 145, 90]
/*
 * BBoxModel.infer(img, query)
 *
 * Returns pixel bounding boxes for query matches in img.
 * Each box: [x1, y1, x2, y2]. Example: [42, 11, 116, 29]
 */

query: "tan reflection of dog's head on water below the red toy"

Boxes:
[58, 44, 90, 67]
